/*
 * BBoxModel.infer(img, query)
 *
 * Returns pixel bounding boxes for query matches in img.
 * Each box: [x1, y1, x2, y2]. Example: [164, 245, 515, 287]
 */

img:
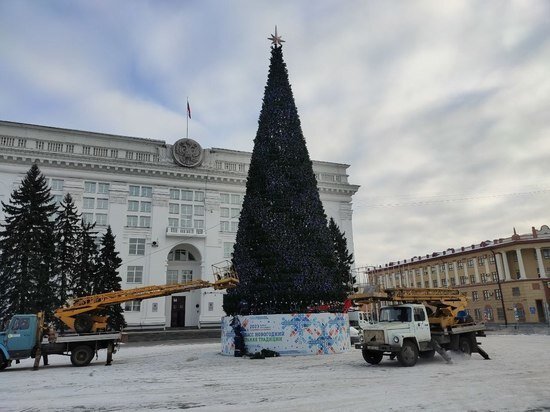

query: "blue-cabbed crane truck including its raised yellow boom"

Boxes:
[0, 273, 239, 370]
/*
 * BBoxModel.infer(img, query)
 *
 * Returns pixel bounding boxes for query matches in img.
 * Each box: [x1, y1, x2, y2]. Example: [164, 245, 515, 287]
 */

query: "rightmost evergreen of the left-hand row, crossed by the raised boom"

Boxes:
[94, 226, 126, 330]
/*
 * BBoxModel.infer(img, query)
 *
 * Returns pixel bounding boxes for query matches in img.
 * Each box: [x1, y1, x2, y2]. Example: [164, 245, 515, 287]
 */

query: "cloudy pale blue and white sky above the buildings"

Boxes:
[0, 0, 550, 266]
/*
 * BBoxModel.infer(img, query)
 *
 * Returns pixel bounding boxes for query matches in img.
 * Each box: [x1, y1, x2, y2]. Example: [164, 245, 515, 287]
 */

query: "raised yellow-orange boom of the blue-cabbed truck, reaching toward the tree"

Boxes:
[54, 273, 239, 333]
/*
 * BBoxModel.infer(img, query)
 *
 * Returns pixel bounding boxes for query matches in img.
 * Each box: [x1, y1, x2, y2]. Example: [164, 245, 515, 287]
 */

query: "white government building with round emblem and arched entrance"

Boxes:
[0, 121, 359, 328]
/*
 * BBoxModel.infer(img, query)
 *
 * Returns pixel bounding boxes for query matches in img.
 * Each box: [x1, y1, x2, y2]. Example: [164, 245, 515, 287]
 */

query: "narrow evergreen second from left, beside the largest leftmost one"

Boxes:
[55, 193, 82, 306]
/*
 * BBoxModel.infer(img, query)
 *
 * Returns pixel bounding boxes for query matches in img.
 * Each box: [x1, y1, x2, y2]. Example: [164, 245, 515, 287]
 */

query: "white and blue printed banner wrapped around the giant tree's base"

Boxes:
[221, 313, 351, 356]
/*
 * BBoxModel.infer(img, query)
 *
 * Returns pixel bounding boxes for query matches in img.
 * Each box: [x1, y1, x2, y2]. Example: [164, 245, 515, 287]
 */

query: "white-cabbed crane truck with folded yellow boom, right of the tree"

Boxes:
[350, 288, 489, 366]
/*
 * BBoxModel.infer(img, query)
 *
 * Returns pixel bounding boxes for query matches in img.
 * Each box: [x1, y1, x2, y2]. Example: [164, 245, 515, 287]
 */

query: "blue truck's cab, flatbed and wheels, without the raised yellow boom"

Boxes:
[0, 313, 127, 371]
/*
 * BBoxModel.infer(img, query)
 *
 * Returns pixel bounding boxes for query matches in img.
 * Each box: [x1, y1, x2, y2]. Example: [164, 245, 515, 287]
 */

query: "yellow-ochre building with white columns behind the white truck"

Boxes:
[363, 226, 550, 324]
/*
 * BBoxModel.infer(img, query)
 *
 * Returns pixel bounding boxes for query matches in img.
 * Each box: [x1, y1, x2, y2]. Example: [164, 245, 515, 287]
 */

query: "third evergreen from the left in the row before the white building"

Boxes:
[71, 220, 98, 297]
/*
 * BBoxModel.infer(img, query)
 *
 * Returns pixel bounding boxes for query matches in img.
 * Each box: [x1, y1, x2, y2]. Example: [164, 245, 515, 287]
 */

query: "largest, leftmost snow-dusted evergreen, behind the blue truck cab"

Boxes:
[0, 164, 56, 319]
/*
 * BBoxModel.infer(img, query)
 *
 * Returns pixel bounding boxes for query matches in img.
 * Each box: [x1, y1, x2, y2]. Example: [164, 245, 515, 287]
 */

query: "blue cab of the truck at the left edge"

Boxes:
[0, 315, 38, 369]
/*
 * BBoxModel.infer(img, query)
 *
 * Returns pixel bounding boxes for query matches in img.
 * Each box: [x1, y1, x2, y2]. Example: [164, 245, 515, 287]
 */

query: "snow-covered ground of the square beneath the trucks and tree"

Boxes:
[0, 335, 550, 412]
